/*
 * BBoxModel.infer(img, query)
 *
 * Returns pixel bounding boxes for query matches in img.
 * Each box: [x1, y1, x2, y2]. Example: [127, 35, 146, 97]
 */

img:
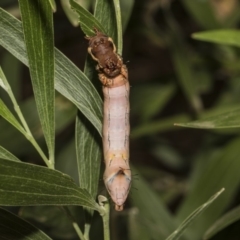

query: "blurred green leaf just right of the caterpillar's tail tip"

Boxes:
[129, 166, 177, 240]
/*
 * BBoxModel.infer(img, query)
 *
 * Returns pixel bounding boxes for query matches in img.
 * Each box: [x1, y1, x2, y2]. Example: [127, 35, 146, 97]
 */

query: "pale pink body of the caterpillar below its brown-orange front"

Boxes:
[103, 82, 131, 211]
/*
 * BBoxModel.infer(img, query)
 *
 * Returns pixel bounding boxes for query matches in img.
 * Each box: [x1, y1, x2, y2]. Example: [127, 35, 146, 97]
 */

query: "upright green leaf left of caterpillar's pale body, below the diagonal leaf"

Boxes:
[75, 113, 102, 198]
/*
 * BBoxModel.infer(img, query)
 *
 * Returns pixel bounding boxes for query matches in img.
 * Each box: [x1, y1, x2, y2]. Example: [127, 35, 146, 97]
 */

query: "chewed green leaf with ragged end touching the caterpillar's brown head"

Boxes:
[70, 0, 106, 36]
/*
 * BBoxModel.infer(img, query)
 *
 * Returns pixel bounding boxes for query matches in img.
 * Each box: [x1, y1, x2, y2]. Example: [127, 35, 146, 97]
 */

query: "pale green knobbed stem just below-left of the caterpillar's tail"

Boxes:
[98, 195, 110, 240]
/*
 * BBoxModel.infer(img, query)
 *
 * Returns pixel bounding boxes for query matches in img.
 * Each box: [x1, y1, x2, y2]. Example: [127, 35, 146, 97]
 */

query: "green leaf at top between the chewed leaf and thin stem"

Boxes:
[94, 0, 118, 47]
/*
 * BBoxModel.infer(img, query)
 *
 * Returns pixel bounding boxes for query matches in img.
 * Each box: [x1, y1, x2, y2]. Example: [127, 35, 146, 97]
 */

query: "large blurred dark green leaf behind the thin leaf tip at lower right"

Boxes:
[177, 138, 240, 239]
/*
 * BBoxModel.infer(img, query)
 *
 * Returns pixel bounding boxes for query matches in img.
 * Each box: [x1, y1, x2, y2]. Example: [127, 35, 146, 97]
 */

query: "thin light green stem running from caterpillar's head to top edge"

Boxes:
[113, 0, 123, 54]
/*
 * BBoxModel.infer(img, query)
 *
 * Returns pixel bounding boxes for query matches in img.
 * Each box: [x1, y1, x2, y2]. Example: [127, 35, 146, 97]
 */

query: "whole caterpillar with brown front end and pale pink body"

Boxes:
[86, 29, 131, 211]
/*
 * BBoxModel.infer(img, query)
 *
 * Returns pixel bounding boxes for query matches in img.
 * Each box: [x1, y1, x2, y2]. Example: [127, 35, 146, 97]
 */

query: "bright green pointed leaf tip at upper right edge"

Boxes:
[192, 29, 240, 47]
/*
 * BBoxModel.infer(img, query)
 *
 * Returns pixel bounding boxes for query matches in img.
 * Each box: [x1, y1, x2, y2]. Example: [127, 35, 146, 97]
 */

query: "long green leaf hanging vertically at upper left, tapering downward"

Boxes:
[19, 0, 55, 162]
